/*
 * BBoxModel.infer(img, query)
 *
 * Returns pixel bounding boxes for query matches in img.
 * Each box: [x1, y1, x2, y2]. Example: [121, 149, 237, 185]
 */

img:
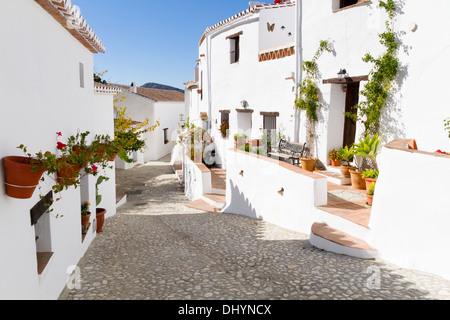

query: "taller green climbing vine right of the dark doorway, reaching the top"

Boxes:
[346, 0, 399, 137]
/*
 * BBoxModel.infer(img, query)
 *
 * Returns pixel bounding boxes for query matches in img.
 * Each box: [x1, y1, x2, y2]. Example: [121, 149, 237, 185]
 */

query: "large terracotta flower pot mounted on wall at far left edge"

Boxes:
[3, 156, 45, 199]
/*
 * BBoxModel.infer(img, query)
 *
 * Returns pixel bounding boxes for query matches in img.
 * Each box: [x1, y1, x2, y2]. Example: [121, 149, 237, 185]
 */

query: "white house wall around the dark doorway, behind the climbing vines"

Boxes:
[300, 0, 450, 163]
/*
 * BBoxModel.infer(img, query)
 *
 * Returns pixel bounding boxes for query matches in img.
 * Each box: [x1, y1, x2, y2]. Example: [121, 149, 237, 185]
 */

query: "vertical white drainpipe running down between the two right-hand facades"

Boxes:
[294, 0, 303, 142]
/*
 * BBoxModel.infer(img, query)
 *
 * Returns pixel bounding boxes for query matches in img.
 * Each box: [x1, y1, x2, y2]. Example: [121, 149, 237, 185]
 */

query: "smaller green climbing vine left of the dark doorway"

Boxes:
[295, 40, 331, 151]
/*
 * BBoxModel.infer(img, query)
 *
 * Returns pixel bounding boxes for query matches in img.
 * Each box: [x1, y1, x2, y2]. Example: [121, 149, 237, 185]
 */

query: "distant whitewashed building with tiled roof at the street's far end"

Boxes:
[114, 82, 185, 169]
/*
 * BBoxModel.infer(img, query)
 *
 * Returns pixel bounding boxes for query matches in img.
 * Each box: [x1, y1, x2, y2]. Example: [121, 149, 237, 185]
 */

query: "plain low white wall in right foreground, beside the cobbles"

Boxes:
[369, 142, 450, 279]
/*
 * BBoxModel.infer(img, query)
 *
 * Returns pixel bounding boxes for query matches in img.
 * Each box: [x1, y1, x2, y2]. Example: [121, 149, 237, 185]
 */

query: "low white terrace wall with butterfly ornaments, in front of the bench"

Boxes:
[224, 150, 327, 234]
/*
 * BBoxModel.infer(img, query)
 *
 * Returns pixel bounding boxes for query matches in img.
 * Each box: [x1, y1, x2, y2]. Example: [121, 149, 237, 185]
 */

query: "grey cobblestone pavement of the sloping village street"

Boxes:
[62, 155, 450, 300]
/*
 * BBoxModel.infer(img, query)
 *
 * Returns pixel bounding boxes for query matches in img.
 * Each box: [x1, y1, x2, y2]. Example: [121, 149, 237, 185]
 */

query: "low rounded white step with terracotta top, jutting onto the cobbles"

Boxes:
[309, 222, 378, 259]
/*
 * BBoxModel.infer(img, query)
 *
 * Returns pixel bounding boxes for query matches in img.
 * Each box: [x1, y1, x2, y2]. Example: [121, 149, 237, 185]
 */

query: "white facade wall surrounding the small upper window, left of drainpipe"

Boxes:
[200, 7, 295, 168]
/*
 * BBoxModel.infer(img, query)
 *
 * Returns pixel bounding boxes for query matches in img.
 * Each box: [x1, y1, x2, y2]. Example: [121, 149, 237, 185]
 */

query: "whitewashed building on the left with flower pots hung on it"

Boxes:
[0, 0, 116, 299]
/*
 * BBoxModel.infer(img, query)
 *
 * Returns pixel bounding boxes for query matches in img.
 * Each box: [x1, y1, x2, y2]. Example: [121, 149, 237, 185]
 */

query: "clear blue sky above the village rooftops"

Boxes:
[72, 0, 273, 89]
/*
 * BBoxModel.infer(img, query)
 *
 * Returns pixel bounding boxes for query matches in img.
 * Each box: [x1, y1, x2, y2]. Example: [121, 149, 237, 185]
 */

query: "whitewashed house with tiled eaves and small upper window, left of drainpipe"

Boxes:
[186, 2, 297, 166]
